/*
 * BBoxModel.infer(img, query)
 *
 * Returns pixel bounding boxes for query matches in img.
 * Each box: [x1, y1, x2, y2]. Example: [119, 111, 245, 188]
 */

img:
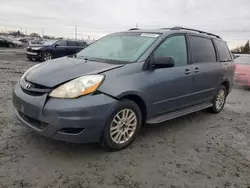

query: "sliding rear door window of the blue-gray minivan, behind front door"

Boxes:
[190, 36, 216, 63]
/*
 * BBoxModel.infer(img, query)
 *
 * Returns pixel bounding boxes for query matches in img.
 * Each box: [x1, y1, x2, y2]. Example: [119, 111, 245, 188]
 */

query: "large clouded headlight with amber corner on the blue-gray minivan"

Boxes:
[49, 75, 104, 99]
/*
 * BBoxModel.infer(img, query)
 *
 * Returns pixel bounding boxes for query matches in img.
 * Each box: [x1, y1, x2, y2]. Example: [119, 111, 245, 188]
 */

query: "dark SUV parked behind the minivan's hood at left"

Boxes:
[26, 40, 87, 61]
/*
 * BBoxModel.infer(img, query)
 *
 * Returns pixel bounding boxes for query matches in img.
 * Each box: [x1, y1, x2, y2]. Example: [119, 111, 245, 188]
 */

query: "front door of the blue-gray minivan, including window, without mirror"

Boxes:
[147, 34, 192, 116]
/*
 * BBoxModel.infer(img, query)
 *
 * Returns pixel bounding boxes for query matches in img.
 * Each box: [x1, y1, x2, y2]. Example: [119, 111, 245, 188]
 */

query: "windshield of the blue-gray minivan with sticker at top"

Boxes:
[77, 32, 159, 62]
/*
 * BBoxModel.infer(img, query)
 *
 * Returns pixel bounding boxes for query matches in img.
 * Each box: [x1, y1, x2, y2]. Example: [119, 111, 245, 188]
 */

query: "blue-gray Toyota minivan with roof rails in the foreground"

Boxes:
[13, 27, 235, 151]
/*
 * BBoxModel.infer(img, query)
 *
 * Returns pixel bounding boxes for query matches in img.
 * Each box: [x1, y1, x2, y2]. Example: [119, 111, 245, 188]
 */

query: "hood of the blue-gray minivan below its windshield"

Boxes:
[25, 57, 124, 87]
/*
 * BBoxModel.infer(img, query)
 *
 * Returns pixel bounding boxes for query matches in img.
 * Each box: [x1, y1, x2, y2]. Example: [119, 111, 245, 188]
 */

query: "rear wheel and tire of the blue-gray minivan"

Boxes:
[209, 85, 228, 114]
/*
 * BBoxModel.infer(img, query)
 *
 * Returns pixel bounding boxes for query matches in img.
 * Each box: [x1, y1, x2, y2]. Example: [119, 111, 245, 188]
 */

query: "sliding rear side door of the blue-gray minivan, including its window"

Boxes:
[189, 36, 223, 104]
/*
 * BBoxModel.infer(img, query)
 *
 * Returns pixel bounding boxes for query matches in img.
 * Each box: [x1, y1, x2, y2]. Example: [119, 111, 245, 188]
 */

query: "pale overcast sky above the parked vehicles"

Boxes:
[0, 0, 250, 47]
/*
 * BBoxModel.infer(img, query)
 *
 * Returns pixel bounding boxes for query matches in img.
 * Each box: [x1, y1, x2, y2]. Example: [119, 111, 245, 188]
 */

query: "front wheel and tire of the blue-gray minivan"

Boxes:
[101, 100, 142, 151]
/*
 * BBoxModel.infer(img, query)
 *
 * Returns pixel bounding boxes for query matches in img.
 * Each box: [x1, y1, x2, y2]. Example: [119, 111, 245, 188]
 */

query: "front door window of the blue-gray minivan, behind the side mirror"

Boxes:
[154, 35, 187, 66]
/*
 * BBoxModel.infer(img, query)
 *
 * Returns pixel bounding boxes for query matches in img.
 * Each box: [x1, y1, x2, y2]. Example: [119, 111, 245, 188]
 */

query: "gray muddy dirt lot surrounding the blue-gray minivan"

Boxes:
[0, 50, 250, 188]
